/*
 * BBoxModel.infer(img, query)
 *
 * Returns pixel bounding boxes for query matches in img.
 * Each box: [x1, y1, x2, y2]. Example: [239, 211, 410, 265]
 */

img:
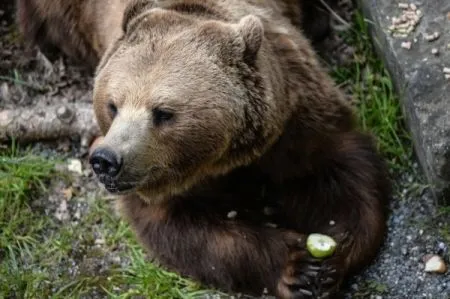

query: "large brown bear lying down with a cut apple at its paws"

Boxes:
[16, 0, 391, 298]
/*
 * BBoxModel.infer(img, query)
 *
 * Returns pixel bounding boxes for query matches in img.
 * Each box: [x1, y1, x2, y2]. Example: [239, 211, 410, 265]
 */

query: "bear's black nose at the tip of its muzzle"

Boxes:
[89, 147, 122, 177]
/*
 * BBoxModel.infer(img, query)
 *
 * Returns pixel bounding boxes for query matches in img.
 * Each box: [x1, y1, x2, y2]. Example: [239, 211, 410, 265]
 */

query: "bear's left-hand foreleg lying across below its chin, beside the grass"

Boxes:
[120, 196, 316, 299]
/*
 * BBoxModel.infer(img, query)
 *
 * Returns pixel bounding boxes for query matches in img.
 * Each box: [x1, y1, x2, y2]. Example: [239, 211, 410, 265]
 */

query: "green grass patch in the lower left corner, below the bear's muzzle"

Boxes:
[0, 147, 215, 299]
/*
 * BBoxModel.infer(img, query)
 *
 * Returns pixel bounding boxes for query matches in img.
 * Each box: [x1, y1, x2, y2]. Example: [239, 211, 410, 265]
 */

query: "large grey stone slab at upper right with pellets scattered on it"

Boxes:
[359, 0, 450, 204]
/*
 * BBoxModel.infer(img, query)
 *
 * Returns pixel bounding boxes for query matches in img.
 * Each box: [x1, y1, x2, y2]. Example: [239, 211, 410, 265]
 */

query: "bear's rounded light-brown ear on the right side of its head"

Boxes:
[237, 15, 264, 61]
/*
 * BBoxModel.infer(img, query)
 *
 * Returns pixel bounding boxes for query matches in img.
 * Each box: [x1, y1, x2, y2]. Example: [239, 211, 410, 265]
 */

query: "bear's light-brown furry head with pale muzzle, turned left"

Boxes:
[90, 5, 280, 199]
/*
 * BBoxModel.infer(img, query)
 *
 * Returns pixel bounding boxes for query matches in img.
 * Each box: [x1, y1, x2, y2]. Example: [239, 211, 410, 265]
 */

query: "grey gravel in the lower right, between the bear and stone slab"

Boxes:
[346, 163, 450, 299]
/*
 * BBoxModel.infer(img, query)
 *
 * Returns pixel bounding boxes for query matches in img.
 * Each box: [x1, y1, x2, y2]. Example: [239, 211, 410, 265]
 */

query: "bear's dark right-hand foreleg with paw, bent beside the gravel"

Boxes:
[278, 133, 391, 298]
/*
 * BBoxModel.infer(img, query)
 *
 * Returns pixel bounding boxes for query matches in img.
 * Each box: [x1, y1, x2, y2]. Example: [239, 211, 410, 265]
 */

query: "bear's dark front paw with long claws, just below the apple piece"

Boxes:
[277, 234, 343, 299]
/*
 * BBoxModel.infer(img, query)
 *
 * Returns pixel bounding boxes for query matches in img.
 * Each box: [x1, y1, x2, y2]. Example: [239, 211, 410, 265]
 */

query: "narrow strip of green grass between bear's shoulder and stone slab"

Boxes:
[332, 14, 412, 170]
